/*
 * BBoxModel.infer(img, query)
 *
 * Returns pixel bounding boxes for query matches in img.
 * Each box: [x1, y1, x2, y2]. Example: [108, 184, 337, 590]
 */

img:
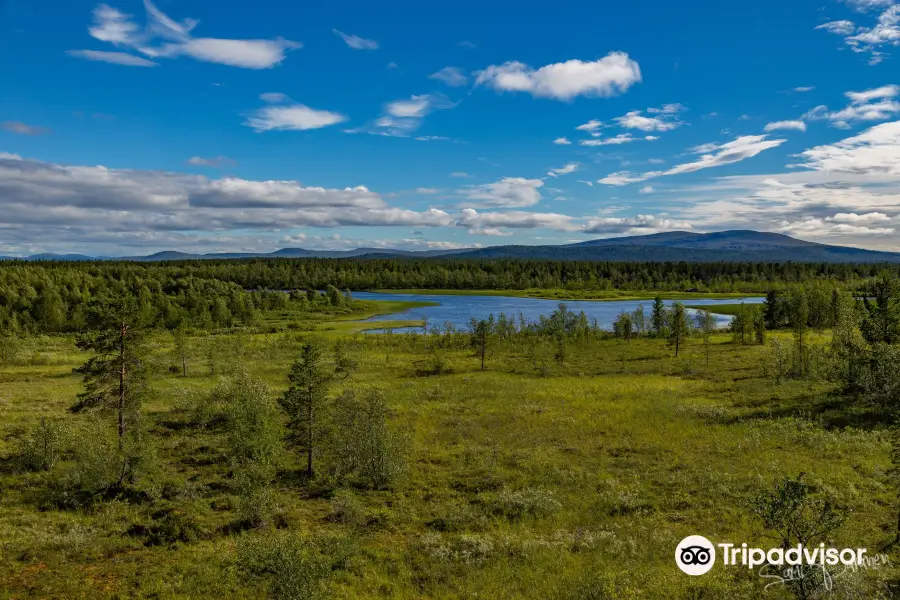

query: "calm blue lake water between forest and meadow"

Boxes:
[353, 292, 763, 333]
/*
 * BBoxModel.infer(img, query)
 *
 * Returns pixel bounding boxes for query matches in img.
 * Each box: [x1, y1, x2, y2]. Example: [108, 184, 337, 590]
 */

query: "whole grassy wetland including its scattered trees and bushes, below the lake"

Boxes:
[0, 260, 900, 600]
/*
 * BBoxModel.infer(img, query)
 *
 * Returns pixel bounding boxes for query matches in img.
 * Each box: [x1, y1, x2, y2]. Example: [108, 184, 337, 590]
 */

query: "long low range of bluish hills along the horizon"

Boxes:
[3, 230, 900, 263]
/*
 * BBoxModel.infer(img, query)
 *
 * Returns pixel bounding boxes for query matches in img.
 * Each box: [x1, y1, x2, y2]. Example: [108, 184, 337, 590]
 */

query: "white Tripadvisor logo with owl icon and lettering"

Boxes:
[675, 535, 868, 575]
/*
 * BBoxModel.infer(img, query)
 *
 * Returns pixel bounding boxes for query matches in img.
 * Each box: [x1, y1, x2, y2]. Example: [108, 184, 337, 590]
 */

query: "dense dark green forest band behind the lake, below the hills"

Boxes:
[0, 259, 900, 331]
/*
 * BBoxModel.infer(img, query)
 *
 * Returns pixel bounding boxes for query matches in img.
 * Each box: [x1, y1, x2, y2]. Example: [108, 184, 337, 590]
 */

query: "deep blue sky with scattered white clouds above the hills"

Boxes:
[0, 0, 900, 255]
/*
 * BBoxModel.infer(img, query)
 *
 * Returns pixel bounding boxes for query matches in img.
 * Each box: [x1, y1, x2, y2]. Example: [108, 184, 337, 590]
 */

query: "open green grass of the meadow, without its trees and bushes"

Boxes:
[0, 302, 900, 600]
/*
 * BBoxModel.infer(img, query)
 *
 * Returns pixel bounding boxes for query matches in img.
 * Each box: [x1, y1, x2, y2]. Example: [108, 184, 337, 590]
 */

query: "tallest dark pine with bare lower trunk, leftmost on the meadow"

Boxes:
[72, 295, 147, 451]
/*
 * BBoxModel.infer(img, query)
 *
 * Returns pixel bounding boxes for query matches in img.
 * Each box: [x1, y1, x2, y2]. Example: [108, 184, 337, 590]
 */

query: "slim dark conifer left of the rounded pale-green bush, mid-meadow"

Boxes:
[279, 341, 331, 477]
